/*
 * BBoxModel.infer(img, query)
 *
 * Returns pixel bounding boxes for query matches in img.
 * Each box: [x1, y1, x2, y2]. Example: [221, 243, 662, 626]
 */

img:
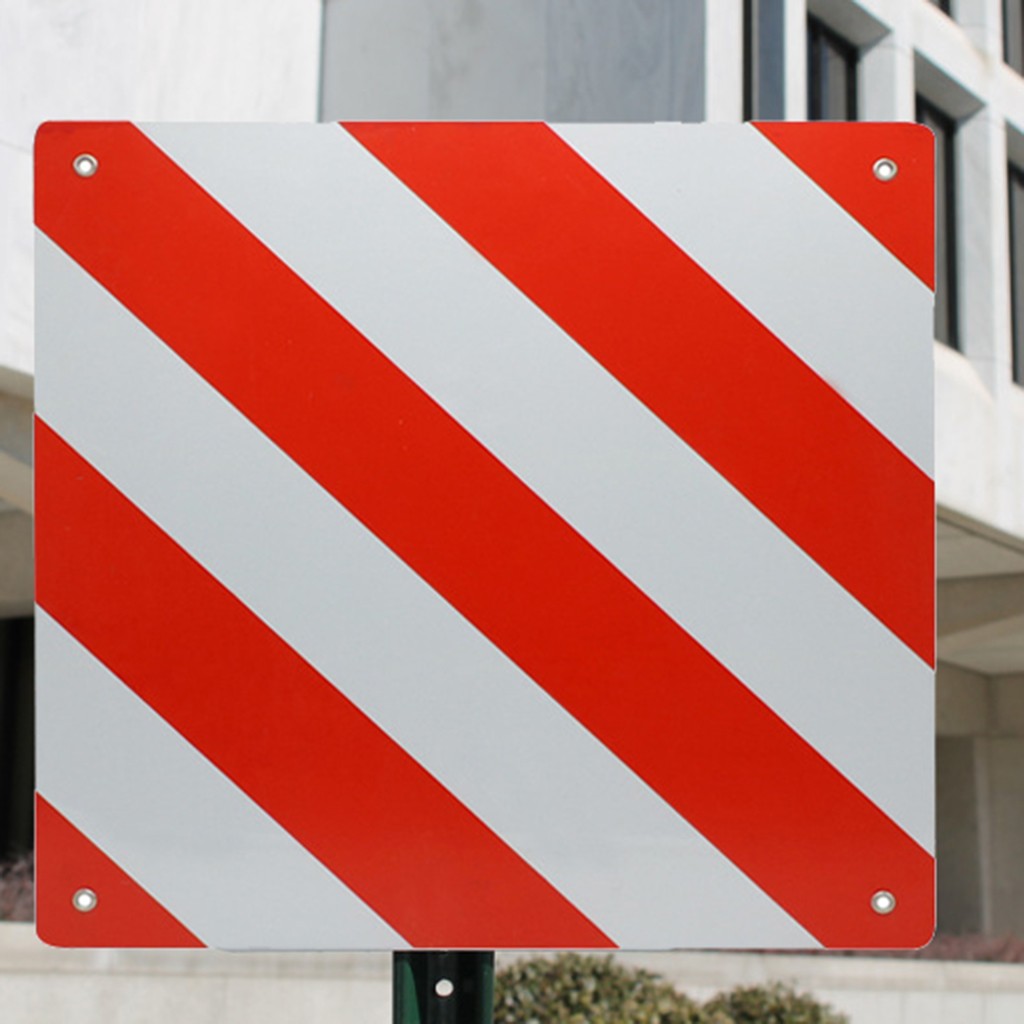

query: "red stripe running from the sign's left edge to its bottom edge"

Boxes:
[36, 421, 613, 948]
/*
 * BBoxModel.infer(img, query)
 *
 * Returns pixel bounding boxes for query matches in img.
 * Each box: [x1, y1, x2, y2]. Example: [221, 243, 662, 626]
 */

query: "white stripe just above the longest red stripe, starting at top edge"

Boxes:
[140, 125, 934, 849]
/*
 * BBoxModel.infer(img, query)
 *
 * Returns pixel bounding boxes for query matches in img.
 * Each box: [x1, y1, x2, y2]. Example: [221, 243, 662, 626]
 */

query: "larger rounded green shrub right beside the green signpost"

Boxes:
[495, 953, 704, 1024]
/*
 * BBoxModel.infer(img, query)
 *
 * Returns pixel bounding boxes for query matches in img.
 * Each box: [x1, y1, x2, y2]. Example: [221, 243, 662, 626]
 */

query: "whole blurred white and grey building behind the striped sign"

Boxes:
[0, 0, 1024, 935]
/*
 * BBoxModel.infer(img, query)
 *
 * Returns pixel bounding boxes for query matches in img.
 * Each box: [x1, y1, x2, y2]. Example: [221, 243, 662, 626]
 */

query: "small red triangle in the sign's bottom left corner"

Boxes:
[36, 794, 203, 949]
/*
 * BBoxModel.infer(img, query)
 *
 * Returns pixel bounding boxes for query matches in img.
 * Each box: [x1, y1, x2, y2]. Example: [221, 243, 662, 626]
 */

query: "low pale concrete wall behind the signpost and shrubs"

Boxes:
[0, 925, 1024, 1024]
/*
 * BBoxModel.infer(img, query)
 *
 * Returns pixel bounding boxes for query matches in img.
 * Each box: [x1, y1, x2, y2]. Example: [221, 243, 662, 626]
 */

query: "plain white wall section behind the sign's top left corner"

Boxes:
[0, 0, 321, 385]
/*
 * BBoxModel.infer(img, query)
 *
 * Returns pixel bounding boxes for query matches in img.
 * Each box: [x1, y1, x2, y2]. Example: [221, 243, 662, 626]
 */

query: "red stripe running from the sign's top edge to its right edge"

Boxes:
[347, 124, 935, 664]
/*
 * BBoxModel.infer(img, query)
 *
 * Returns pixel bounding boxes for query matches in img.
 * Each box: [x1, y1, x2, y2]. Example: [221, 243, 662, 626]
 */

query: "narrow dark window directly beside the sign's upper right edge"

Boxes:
[918, 96, 959, 348]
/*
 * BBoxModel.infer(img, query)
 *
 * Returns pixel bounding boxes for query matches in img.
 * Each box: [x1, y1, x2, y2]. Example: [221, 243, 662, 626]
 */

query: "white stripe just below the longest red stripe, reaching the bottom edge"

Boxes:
[36, 238, 817, 947]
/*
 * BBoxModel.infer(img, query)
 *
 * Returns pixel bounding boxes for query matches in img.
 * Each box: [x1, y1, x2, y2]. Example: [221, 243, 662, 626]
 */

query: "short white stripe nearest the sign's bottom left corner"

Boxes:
[36, 608, 407, 949]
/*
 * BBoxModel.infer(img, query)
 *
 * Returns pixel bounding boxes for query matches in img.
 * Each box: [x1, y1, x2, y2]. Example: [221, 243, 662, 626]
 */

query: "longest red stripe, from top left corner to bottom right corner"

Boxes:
[37, 126, 932, 945]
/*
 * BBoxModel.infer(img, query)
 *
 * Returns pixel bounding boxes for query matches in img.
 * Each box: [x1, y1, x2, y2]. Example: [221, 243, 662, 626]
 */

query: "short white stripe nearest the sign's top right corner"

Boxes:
[556, 124, 934, 476]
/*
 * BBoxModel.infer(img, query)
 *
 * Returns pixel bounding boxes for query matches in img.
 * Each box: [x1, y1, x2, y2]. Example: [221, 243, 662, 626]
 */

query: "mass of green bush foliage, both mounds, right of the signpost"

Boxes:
[495, 953, 849, 1024]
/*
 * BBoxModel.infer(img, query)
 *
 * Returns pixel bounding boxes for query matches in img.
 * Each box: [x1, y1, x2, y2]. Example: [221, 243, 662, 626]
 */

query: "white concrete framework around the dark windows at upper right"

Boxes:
[745, 0, 1024, 537]
